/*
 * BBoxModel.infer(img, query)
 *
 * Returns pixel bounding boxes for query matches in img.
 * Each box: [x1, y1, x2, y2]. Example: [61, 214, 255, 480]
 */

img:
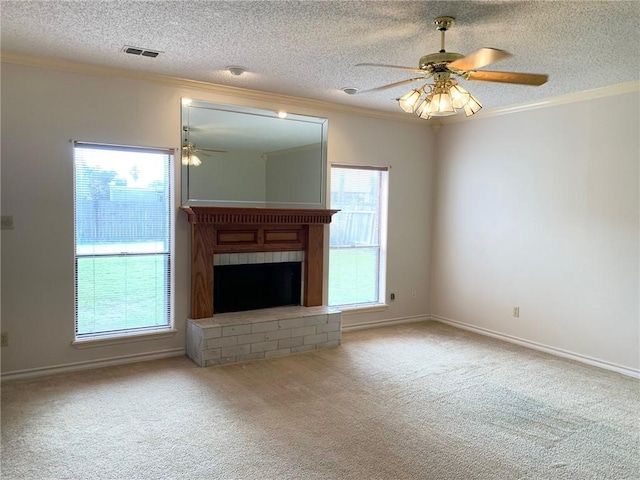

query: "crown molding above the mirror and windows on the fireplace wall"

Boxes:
[0, 51, 420, 123]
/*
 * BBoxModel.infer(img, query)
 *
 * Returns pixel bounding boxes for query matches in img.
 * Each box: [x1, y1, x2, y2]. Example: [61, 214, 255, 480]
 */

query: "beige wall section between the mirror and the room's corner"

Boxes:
[325, 115, 435, 326]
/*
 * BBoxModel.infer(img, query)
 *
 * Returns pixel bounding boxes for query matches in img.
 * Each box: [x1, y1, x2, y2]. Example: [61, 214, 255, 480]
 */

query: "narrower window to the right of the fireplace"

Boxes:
[329, 164, 388, 306]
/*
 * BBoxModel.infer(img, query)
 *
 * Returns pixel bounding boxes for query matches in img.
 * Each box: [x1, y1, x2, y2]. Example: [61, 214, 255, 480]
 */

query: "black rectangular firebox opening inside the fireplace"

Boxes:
[213, 262, 302, 314]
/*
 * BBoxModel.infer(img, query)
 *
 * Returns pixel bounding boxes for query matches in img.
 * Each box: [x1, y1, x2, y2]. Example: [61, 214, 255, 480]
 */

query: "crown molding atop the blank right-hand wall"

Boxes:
[438, 81, 640, 125]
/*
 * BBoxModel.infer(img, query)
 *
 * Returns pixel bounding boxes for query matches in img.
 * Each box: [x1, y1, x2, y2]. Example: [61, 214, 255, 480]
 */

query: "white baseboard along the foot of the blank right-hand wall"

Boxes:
[431, 315, 640, 378]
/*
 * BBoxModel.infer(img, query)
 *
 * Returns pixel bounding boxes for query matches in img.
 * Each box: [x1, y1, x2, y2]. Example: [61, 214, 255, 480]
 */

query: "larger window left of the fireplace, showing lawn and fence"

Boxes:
[74, 142, 173, 339]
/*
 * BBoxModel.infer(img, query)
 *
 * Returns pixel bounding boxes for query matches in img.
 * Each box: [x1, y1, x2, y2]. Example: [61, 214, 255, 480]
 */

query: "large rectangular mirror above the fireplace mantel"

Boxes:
[181, 99, 328, 209]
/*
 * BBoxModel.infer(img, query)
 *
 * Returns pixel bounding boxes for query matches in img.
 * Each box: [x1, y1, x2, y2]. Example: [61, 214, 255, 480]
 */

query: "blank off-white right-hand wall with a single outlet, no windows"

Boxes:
[431, 92, 640, 369]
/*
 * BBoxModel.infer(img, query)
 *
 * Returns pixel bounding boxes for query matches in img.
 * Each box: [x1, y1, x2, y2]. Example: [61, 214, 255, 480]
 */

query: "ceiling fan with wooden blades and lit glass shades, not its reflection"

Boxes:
[342, 17, 549, 119]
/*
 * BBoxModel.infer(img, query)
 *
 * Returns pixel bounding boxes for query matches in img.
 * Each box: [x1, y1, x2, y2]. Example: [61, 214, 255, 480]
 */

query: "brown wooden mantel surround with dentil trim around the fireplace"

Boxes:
[181, 206, 338, 319]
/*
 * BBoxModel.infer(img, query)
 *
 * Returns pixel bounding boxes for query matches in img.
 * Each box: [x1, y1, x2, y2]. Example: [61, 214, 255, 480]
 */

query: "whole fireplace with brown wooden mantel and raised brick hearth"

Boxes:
[182, 206, 342, 367]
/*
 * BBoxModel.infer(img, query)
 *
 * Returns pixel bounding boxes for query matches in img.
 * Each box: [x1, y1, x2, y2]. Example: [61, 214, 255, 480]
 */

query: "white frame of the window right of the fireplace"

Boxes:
[327, 163, 391, 312]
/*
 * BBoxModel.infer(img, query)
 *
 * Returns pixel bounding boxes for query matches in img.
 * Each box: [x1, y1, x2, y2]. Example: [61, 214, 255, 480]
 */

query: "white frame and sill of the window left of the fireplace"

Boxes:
[72, 141, 177, 348]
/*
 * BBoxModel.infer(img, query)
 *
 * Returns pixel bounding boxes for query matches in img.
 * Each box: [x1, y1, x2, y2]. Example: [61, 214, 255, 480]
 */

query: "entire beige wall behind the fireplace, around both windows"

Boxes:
[1, 63, 433, 374]
